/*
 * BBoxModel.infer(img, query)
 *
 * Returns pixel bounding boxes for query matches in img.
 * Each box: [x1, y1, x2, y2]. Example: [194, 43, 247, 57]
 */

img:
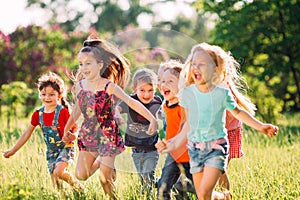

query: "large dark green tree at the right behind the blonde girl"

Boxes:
[195, 0, 300, 112]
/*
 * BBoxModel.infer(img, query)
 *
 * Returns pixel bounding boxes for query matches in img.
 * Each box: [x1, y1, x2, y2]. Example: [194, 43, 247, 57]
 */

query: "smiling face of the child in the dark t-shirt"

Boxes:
[134, 81, 154, 104]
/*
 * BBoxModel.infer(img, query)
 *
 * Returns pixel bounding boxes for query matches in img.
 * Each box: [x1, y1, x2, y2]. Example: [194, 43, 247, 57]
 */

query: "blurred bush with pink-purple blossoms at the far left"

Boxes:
[0, 26, 87, 87]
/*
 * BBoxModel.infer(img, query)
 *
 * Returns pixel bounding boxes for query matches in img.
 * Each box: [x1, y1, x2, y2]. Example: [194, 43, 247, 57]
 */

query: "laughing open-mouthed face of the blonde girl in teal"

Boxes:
[191, 51, 216, 85]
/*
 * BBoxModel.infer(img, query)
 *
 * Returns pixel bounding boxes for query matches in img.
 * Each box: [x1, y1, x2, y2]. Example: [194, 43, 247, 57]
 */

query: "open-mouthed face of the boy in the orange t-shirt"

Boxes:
[161, 70, 179, 102]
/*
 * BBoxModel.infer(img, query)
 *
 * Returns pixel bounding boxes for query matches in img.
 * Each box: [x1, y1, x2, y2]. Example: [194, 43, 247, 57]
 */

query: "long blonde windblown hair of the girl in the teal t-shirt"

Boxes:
[179, 43, 256, 115]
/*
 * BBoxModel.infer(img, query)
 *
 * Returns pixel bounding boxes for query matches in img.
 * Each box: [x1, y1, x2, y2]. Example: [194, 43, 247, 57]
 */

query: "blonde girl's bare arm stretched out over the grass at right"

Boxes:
[230, 106, 278, 137]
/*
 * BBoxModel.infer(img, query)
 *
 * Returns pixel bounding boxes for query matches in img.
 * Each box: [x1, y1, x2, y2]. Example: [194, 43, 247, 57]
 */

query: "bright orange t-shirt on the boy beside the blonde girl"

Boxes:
[163, 102, 190, 163]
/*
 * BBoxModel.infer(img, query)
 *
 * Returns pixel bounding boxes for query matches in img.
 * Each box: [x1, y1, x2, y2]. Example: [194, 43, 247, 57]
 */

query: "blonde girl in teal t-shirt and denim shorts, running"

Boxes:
[156, 43, 278, 199]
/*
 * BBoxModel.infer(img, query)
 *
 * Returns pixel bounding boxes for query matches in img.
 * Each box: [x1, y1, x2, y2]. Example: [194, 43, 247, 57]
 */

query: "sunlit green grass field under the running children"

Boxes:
[0, 114, 300, 200]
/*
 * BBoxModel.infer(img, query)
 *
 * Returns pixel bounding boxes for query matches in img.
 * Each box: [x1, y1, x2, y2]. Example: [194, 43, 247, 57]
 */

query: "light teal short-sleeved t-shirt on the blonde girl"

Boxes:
[180, 84, 237, 143]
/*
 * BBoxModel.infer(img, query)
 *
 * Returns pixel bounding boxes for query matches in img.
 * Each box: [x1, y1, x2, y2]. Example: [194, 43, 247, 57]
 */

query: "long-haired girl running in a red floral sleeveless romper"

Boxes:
[64, 36, 157, 199]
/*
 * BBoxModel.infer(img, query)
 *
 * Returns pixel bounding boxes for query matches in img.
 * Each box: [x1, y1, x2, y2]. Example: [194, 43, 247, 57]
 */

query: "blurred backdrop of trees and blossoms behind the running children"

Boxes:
[0, 0, 300, 122]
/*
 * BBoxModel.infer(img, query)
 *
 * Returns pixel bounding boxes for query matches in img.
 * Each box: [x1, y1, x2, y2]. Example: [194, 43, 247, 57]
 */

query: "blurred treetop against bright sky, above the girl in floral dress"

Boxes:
[27, 0, 153, 33]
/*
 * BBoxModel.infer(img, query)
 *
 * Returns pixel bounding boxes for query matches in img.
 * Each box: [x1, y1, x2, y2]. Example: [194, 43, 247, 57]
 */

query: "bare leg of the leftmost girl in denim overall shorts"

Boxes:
[53, 162, 83, 189]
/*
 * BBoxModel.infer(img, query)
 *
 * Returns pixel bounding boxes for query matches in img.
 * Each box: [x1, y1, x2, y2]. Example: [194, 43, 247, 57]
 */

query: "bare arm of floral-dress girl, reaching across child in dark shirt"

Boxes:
[107, 83, 157, 134]
